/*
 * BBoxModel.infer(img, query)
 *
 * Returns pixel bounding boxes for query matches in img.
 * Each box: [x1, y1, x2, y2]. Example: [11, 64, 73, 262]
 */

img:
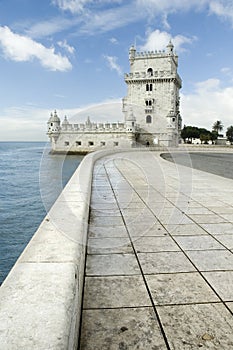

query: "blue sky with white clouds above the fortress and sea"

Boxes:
[0, 0, 233, 141]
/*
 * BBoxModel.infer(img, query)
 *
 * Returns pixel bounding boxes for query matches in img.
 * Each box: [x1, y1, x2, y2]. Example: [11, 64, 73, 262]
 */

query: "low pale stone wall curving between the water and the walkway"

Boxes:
[0, 150, 132, 350]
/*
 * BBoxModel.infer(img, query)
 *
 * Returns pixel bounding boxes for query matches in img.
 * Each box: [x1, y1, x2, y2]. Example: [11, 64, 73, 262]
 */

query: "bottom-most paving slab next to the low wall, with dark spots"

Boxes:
[81, 307, 166, 350]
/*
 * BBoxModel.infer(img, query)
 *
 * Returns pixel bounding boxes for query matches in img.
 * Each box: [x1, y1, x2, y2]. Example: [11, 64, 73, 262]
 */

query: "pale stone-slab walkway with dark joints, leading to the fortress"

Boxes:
[81, 152, 233, 350]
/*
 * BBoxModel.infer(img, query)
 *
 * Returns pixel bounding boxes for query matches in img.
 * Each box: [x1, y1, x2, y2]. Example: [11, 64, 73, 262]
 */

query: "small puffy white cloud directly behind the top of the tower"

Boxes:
[140, 29, 196, 52]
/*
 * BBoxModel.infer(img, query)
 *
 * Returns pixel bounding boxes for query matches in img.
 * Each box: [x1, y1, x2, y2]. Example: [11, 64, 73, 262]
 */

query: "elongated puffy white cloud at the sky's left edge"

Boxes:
[0, 27, 72, 71]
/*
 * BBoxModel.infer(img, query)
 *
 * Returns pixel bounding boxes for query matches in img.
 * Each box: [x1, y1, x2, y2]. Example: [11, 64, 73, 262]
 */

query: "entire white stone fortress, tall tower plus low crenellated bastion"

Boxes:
[47, 42, 181, 153]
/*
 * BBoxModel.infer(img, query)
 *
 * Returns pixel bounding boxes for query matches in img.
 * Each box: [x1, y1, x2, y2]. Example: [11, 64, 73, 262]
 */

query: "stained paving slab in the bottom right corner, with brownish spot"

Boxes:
[157, 303, 233, 350]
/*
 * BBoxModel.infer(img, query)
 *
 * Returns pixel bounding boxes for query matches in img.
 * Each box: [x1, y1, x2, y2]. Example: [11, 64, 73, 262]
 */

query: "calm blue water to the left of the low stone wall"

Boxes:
[0, 142, 83, 284]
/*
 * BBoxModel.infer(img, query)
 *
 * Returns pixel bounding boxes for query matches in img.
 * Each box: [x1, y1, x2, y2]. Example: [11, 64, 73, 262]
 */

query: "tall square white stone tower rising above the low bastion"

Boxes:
[123, 41, 181, 147]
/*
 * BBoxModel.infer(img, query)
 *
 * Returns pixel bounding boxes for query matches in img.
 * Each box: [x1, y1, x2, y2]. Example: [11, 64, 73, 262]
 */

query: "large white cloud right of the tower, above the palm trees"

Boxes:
[181, 79, 233, 130]
